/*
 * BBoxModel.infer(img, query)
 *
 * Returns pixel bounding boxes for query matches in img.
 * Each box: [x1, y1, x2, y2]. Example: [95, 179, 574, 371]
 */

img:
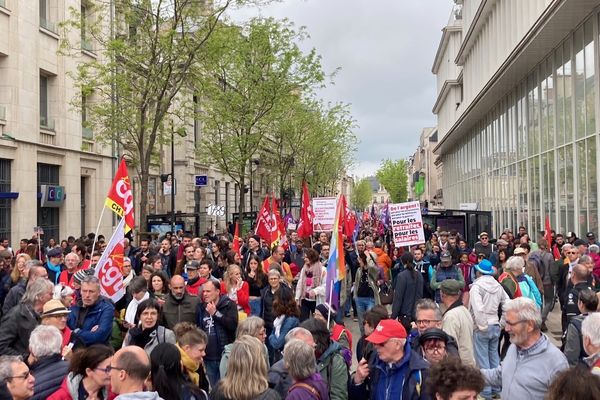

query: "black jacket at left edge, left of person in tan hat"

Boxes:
[0, 303, 39, 356]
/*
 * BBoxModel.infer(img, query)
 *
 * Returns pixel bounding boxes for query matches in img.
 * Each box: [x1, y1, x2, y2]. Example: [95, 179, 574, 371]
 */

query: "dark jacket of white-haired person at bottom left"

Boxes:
[31, 354, 69, 400]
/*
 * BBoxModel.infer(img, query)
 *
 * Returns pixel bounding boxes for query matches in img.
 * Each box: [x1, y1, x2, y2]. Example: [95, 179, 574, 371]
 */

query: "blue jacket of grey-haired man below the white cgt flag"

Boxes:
[67, 297, 115, 346]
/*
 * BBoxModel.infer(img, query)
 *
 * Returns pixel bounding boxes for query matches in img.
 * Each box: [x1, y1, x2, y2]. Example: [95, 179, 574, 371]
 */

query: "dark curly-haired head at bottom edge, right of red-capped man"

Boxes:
[428, 358, 484, 400]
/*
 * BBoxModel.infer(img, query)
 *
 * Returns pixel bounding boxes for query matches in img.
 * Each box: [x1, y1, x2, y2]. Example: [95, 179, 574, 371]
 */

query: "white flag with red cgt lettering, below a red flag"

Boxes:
[94, 218, 125, 302]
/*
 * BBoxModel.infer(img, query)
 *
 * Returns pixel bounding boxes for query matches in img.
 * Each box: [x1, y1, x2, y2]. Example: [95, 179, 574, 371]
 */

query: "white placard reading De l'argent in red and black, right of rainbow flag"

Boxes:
[389, 201, 425, 247]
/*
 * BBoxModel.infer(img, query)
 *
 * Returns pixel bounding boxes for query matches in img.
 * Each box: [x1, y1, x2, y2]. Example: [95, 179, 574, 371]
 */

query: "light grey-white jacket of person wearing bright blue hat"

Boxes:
[469, 275, 510, 332]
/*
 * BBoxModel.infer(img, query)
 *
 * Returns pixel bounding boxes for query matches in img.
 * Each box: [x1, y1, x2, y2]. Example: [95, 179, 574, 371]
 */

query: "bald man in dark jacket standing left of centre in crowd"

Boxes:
[161, 275, 198, 329]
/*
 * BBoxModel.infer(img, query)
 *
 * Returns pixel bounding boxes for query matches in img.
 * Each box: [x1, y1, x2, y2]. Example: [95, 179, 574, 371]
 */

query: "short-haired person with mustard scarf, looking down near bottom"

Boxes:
[173, 322, 209, 392]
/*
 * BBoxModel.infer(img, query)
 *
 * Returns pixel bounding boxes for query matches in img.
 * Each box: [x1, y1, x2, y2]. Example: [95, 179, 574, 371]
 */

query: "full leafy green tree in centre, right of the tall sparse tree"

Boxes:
[197, 19, 325, 222]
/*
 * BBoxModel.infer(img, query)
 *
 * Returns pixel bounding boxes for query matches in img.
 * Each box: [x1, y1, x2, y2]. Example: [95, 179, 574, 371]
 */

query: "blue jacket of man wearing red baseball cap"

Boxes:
[348, 343, 431, 400]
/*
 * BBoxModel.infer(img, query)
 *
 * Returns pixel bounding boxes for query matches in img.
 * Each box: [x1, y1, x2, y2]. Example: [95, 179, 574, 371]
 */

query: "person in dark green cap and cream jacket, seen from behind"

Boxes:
[440, 279, 475, 365]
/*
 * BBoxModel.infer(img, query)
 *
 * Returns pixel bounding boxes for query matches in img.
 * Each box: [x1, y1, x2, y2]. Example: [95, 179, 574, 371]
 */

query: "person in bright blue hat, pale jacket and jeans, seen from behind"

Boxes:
[469, 260, 510, 400]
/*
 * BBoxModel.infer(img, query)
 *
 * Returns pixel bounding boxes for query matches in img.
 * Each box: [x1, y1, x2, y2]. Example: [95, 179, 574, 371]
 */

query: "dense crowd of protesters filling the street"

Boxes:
[0, 227, 600, 400]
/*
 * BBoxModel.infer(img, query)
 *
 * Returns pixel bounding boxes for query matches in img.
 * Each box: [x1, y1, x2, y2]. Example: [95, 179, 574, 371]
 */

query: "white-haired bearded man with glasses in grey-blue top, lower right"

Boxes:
[481, 297, 569, 400]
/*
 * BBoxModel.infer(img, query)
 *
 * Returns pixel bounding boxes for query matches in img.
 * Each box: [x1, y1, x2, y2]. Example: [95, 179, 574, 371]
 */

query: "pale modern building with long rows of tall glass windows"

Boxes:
[433, 0, 600, 236]
